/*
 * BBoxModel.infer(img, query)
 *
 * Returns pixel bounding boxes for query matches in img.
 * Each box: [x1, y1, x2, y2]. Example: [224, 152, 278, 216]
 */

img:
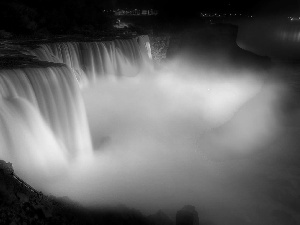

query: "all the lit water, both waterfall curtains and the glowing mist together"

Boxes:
[0, 34, 298, 224]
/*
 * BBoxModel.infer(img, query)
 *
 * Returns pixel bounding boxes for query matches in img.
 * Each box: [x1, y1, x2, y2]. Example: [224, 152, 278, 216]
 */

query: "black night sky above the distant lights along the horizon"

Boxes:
[11, 0, 300, 13]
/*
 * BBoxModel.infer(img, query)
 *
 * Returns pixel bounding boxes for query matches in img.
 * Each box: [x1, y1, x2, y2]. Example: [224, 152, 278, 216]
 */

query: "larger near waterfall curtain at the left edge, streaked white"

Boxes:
[0, 66, 92, 159]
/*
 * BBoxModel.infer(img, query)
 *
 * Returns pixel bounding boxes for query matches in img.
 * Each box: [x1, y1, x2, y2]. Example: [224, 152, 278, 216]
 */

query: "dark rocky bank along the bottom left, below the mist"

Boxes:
[0, 160, 173, 225]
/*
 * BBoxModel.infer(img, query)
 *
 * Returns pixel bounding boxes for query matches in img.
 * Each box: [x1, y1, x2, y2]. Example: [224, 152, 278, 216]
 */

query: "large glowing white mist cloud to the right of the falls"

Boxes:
[14, 59, 292, 224]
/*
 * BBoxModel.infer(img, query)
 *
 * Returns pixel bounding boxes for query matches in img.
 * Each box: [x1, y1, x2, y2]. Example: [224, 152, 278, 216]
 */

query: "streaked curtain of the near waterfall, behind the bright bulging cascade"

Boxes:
[0, 67, 91, 155]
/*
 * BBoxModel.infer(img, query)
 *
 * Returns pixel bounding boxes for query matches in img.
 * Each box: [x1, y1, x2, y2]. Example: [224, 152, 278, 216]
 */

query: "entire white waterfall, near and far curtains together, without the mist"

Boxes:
[0, 36, 151, 168]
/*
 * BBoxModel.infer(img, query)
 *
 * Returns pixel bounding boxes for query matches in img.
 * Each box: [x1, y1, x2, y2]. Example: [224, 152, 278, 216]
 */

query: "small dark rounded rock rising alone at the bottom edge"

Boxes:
[176, 205, 200, 225]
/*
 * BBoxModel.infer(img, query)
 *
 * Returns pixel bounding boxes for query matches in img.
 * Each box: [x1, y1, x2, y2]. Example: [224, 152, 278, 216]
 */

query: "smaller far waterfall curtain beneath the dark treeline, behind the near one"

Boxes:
[29, 36, 152, 86]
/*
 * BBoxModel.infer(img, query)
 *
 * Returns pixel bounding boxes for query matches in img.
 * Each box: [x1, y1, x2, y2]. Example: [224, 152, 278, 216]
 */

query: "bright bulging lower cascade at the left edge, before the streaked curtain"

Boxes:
[0, 97, 68, 178]
